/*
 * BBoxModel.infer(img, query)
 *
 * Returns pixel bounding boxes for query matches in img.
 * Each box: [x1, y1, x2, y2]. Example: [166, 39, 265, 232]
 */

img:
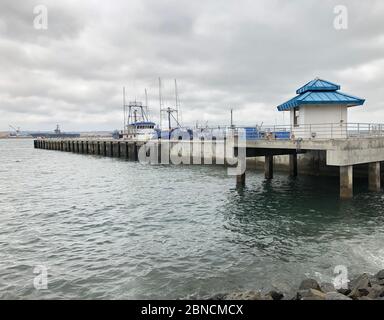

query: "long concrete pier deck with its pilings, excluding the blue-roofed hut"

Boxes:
[34, 137, 384, 199]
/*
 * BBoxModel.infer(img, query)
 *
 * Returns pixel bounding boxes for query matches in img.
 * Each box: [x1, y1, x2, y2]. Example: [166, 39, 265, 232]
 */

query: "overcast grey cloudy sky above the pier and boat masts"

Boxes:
[0, 0, 384, 131]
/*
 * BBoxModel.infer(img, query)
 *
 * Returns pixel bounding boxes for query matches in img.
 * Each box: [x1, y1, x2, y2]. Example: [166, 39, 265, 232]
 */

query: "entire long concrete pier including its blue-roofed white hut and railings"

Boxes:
[34, 78, 384, 199]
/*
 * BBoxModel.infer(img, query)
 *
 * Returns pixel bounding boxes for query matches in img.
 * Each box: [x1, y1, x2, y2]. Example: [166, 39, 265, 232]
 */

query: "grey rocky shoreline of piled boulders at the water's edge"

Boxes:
[208, 269, 384, 300]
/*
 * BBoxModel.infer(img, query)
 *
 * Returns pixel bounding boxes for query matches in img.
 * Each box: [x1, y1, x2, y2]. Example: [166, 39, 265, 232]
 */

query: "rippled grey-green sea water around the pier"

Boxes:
[0, 140, 384, 299]
